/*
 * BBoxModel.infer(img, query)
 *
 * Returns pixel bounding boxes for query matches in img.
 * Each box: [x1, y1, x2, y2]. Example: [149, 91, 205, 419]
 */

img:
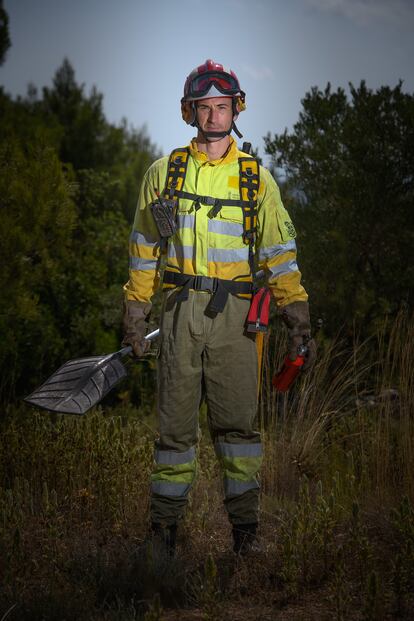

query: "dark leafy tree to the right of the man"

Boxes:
[265, 82, 414, 330]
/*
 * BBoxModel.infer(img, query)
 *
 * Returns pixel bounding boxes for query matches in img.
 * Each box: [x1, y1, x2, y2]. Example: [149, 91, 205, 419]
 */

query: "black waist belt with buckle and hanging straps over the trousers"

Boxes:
[163, 270, 253, 313]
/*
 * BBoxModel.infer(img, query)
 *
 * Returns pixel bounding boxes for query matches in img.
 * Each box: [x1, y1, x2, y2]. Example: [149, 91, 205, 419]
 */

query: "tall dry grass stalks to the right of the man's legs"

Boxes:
[260, 312, 414, 500]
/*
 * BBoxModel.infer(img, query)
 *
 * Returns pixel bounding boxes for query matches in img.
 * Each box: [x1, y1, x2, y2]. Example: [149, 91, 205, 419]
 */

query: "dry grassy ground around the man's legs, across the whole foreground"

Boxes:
[0, 315, 414, 621]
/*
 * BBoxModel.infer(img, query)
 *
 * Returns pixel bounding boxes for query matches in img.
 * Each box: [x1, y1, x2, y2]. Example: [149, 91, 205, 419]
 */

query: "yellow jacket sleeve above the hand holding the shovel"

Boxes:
[124, 158, 168, 302]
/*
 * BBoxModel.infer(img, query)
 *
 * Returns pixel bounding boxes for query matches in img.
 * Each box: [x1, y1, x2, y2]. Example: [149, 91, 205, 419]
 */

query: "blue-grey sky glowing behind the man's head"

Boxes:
[0, 0, 414, 163]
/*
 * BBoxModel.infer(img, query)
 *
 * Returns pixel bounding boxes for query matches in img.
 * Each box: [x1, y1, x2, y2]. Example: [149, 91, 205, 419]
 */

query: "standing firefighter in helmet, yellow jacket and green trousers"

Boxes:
[124, 60, 315, 553]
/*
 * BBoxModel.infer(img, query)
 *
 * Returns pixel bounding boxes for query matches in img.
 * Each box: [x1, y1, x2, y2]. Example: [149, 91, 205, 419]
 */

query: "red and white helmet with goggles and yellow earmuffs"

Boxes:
[181, 59, 246, 125]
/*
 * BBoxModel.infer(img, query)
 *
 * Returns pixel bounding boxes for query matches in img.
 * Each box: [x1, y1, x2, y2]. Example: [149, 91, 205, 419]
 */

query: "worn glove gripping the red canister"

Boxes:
[282, 302, 316, 371]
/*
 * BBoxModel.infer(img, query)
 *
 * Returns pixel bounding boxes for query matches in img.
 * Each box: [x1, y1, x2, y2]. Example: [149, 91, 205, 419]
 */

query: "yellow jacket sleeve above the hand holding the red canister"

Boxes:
[256, 167, 308, 307]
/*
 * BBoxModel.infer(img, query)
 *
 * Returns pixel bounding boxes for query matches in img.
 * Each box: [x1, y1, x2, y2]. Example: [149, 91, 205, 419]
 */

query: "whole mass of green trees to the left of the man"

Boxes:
[0, 60, 160, 401]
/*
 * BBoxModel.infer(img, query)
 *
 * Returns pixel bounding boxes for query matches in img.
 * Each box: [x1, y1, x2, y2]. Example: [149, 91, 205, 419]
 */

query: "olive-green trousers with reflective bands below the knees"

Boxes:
[151, 291, 262, 526]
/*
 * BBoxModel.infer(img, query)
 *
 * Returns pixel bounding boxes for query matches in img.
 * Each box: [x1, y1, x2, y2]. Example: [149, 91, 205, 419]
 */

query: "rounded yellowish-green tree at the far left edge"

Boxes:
[0, 138, 76, 400]
